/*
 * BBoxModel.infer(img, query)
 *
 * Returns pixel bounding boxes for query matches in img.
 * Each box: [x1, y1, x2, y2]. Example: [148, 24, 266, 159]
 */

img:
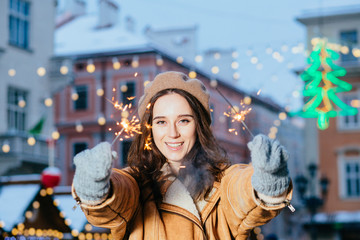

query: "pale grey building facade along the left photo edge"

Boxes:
[0, 0, 56, 175]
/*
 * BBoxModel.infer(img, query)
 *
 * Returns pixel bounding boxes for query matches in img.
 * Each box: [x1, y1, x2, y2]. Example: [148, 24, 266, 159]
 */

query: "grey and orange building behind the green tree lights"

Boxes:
[297, 5, 360, 239]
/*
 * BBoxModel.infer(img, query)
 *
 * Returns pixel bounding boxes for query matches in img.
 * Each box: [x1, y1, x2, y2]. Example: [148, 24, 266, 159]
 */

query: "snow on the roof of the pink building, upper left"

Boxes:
[55, 14, 148, 56]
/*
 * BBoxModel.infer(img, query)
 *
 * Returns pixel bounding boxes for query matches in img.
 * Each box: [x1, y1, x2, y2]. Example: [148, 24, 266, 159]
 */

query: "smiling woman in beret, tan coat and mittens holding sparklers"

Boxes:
[73, 72, 292, 239]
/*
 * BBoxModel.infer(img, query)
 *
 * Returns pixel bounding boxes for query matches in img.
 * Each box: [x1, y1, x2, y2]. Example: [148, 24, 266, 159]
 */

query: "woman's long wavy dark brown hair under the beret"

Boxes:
[128, 89, 230, 201]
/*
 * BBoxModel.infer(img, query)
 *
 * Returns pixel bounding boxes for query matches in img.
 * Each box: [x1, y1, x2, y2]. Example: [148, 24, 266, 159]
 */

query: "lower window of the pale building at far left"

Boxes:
[7, 87, 28, 131]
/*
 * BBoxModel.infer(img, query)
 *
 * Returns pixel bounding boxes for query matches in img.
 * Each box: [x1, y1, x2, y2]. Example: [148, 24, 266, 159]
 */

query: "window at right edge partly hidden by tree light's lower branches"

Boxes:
[338, 91, 360, 130]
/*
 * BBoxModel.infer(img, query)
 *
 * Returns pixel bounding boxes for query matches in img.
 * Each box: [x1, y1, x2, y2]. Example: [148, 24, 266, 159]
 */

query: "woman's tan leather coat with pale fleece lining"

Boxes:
[73, 164, 292, 240]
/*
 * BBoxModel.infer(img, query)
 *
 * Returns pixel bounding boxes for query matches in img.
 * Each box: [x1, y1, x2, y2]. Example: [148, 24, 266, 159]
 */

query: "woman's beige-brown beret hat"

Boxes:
[138, 71, 210, 119]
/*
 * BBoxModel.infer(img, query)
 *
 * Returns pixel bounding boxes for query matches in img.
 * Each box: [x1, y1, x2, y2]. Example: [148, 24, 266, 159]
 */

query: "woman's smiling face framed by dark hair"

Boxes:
[152, 93, 196, 168]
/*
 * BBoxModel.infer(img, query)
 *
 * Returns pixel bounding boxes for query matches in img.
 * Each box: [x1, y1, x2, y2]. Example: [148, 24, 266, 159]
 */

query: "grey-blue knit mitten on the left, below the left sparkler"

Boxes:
[73, 142, 117, 205]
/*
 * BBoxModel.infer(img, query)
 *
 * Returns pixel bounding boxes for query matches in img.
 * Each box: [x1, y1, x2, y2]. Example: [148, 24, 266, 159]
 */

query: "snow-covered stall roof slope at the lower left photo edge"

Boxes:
[0, 184, 40, 231]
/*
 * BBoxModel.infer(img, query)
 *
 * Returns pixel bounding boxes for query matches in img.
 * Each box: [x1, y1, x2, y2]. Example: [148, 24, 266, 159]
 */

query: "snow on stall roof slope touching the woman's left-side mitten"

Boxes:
[54, 194, 87, 232]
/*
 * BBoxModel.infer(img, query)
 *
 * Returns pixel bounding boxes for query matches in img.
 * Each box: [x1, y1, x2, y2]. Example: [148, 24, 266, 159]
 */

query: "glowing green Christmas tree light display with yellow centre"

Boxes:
[292, 40, 357, 130]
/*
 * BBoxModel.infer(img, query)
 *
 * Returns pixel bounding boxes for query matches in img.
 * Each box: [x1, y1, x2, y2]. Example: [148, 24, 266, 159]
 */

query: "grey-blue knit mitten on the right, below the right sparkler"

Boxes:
[248, 134, 290, 196]
